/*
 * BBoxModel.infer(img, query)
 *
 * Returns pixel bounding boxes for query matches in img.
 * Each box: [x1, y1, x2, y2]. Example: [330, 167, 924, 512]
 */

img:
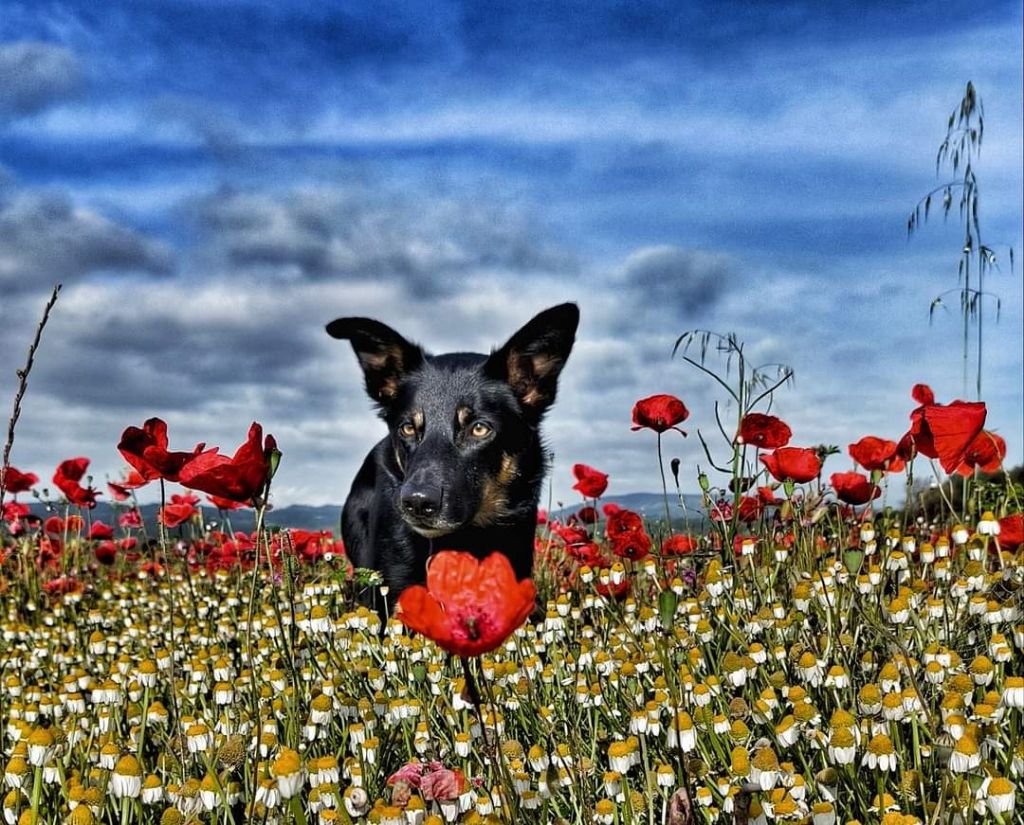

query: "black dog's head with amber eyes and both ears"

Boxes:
[327, 304, 580, 537]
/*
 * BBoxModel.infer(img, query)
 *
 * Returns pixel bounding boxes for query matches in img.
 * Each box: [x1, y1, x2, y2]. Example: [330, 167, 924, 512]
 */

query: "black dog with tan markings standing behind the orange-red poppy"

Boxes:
[327, 304, 580, 604]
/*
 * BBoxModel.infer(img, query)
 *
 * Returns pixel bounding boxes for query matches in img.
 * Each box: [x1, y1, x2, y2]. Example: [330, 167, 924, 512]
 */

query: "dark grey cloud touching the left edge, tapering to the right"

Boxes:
[0, 191, 172, 292]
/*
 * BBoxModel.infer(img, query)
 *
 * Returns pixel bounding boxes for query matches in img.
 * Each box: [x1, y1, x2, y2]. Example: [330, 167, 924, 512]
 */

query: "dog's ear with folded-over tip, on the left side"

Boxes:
[327, 318, 423, 406]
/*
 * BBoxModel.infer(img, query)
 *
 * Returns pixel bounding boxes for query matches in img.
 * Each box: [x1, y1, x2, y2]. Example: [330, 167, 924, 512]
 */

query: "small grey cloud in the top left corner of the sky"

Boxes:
[0, 41, 82, 116]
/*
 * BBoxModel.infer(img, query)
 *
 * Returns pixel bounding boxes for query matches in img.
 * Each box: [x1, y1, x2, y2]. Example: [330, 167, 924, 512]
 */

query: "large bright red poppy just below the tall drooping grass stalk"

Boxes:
[898, 384, 987, 473]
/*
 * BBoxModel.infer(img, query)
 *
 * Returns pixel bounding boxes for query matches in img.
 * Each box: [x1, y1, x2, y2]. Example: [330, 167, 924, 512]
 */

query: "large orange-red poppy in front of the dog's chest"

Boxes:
[397, 550, 537, 656]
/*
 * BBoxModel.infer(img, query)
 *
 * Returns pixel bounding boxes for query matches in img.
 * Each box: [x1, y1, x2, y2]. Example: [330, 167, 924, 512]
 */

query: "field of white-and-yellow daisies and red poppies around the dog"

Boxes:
[0, 385, 1024, 825]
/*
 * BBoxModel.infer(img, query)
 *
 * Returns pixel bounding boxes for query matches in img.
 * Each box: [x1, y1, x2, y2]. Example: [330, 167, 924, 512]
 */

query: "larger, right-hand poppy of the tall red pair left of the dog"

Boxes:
[178, 422, 278, 503]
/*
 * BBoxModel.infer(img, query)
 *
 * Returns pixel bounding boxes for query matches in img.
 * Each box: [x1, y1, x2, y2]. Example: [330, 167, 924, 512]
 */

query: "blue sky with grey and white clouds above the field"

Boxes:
[0, 0, 1024, 504]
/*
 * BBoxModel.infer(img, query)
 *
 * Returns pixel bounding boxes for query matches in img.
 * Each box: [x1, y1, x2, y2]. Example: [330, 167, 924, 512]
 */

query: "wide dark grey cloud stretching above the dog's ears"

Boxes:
[197, 189, 575, 297]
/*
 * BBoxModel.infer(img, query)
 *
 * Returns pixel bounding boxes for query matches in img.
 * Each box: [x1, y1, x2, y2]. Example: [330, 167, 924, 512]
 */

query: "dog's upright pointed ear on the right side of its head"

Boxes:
[483, 304, 580, 418]
